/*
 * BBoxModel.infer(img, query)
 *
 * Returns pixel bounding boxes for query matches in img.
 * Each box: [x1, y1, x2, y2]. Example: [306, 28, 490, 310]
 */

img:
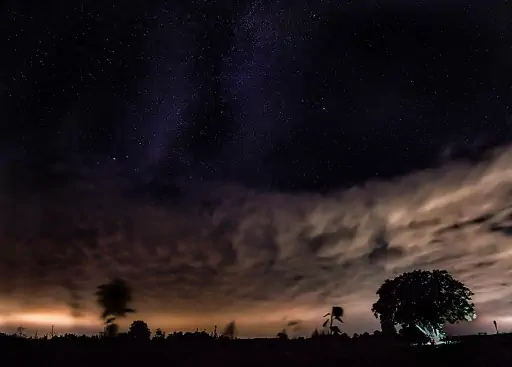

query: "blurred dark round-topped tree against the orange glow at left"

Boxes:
[96, 278, 135, 334]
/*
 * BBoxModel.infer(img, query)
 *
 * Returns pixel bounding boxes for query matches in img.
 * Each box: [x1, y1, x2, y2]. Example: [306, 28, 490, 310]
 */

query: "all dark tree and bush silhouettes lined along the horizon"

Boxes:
[2, 270, 498, 344]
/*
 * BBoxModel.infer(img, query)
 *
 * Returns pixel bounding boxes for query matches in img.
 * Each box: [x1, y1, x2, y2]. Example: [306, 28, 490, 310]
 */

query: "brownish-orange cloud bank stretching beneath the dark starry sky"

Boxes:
[0, 149, 512, 335]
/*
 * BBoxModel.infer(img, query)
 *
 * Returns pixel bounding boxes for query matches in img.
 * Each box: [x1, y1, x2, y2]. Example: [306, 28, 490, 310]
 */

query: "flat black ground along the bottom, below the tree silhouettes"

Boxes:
[0, 336, 512, 367]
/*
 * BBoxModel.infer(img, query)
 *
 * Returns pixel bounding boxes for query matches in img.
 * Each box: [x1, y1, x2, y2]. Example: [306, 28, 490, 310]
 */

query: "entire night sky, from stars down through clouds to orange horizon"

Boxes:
[0, 0, 512, 336]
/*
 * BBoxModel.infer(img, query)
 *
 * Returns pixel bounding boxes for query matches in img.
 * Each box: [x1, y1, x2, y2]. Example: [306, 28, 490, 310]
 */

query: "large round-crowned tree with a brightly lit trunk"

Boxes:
[372, 270, 476, 343]
